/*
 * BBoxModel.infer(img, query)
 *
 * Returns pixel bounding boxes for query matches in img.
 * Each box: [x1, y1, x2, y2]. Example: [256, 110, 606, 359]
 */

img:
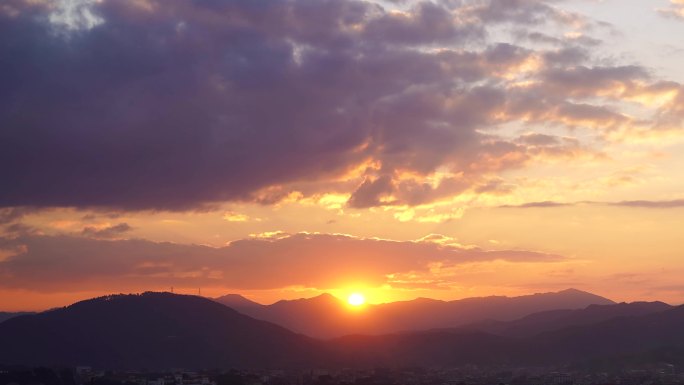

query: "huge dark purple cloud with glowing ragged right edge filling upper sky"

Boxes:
[0, 0, 682, 210]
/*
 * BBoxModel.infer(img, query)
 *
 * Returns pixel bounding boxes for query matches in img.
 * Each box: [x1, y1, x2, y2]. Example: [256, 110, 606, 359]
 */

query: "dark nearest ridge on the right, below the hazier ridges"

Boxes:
[330, 306, 684, 369]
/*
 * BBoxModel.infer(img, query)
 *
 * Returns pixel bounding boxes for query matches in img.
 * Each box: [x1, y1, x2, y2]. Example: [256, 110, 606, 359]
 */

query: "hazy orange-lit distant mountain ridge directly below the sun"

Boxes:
[217, 289, 614, 339]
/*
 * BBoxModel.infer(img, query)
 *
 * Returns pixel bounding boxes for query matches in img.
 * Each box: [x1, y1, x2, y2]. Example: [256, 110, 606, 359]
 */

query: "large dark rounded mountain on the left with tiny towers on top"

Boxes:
[0, 293, 321, 368]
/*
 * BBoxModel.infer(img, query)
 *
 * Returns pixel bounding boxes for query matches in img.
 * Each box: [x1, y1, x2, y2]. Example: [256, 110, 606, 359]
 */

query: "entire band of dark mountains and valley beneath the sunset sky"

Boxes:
[0, 282, 684, 372]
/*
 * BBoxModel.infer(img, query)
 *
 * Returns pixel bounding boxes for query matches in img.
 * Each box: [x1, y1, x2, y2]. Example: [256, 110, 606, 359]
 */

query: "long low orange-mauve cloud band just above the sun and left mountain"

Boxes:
[0, 232, 563, 292]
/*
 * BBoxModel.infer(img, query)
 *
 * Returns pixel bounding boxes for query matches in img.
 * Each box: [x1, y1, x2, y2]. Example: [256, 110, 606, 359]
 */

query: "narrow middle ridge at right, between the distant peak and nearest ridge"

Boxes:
[465, 302, 672, 337]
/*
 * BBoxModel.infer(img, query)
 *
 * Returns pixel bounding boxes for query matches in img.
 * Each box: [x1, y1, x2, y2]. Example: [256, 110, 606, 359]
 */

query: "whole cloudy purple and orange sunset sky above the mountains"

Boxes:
[0, 0, 684, 311]
